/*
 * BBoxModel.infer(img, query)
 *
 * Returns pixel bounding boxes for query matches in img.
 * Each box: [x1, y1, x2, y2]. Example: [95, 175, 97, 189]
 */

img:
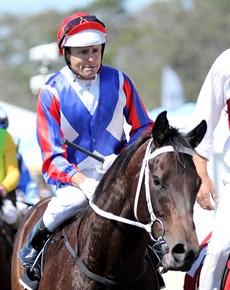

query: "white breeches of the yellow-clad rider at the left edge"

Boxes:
[0, 199, 19, 225]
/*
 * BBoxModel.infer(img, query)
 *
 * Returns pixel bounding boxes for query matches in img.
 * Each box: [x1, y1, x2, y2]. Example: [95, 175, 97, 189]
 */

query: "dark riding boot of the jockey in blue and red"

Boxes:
[19, 218, 52, 279]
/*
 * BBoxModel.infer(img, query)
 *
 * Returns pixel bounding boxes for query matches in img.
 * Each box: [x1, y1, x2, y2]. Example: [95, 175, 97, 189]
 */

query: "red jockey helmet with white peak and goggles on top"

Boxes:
[57, 12, 106, 55]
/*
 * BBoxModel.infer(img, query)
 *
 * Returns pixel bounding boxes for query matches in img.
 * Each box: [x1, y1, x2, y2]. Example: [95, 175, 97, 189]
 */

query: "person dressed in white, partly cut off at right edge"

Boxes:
[191, 49, 230, 290]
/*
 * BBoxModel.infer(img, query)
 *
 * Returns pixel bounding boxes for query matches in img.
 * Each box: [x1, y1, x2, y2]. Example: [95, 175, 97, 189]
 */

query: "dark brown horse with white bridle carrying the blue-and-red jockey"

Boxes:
[12, 111, 207, 290]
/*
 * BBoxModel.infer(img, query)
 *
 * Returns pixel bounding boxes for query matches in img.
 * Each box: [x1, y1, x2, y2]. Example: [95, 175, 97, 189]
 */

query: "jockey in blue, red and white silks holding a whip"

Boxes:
[19, 13, 153, 286]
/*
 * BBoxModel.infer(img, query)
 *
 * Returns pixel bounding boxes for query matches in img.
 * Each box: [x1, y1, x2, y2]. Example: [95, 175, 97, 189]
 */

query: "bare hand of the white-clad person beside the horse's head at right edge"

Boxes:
[197, 175, 218, 210]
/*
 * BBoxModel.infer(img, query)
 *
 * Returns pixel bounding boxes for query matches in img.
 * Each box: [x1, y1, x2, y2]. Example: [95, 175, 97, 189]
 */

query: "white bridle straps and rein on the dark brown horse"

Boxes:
[89, 139, 194, 234]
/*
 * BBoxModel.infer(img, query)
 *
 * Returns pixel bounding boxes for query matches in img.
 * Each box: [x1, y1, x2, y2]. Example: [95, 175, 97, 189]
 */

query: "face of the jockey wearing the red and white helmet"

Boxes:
[69, 44, 102, 80]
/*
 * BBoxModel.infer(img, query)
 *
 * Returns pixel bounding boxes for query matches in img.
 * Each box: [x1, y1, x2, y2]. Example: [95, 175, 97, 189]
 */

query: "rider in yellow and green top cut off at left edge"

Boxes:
[0, 107, 21, 230]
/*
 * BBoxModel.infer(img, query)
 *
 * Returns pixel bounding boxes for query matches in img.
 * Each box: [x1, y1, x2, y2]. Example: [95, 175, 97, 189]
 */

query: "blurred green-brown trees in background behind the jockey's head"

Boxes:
[0, 0, 230, 111]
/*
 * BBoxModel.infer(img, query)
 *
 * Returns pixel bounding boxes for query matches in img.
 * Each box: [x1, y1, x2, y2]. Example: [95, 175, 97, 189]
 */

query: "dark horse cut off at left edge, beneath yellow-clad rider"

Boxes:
[0, 199, 14, 290]
